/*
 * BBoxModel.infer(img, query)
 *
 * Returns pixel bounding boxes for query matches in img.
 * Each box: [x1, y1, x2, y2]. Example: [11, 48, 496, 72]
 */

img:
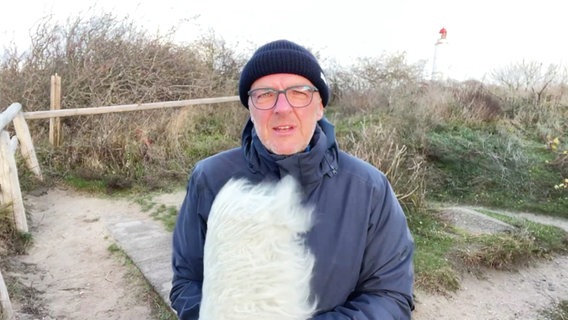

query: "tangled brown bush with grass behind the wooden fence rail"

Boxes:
[0, 14, 245, 188]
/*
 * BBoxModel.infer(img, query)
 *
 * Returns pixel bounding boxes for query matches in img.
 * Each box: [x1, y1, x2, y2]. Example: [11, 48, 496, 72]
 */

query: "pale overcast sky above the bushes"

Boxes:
[0, 0, 568, 80]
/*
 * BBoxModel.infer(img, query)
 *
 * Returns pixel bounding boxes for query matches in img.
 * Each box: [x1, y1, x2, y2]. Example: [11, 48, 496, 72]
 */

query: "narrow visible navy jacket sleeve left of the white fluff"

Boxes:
[170, 167, 208, 320]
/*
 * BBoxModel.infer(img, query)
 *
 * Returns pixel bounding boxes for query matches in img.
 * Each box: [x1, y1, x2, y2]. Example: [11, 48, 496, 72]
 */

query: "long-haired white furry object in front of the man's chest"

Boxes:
[199, 177, 315, 320]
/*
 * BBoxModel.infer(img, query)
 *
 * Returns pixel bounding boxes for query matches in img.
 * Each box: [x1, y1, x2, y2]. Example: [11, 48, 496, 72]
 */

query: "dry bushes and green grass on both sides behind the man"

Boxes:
[0, 10, 568, 308]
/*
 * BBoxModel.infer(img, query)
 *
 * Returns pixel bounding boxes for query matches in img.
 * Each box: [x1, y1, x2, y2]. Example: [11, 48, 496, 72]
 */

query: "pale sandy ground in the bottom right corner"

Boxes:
[413, 257, 568, 320]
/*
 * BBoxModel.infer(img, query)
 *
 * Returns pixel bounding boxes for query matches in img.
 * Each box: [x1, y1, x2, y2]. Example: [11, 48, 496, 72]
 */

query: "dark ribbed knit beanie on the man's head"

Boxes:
[239, 40, 329, 109]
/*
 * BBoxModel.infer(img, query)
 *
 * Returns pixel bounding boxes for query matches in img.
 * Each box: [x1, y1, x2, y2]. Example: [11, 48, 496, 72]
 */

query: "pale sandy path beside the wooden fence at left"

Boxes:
[7, 190, 158, 320]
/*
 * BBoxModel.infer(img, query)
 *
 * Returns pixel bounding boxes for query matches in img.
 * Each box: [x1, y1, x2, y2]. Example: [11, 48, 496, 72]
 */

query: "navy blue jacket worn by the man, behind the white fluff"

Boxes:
[170, 118, 414, 320]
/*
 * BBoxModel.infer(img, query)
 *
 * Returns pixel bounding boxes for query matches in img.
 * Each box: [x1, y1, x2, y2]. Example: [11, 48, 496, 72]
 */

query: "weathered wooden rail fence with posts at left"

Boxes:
[0, 74, 239, 319]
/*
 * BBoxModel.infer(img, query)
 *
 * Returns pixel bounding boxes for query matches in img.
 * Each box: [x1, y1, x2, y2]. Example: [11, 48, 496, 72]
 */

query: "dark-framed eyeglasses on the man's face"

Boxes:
[248, 85, 318, 110]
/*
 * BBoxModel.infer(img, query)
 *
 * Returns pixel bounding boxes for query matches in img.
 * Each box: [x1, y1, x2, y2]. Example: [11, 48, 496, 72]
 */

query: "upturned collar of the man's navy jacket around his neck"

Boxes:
[242, 117, 339, 186]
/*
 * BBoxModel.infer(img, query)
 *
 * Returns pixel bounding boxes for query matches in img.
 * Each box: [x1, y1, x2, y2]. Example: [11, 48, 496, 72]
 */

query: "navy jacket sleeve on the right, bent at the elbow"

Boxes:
[313, 178, 414, 320]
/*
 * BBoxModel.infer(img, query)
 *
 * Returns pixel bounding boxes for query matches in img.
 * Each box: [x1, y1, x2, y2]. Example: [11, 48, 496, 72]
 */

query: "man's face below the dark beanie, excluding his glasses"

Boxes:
[249, 73, 323, 155]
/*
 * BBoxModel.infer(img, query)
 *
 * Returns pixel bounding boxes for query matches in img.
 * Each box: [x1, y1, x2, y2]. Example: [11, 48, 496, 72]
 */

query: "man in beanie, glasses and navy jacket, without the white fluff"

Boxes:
[170, 40, 414, 320]
